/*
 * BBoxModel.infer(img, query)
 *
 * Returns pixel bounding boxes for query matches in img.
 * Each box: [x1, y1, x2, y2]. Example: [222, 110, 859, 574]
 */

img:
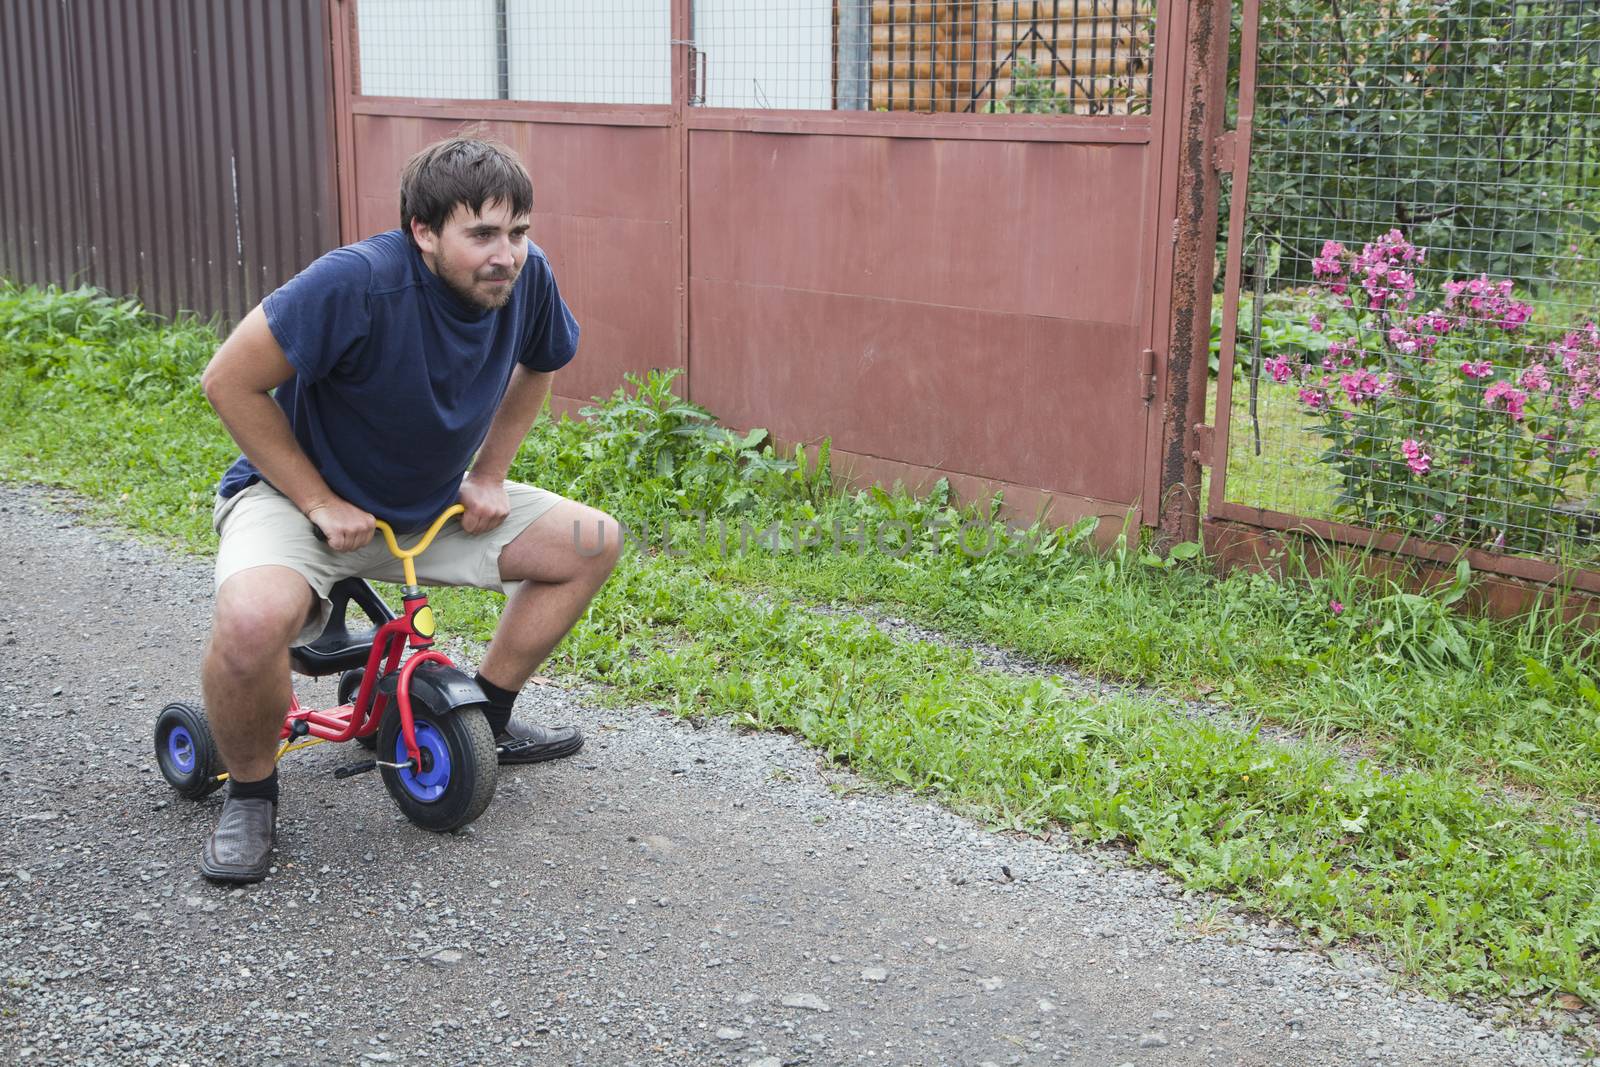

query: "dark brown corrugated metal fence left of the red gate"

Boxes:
[0, 0, 339, 320]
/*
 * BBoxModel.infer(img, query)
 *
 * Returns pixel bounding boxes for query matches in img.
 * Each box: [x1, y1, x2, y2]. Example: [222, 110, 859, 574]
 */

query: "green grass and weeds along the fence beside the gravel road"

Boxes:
[0, 278, 1600, 1001]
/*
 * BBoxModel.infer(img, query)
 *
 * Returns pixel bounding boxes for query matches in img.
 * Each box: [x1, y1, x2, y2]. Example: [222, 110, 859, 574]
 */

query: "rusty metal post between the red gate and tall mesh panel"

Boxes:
[1158, 0, 1232, 542]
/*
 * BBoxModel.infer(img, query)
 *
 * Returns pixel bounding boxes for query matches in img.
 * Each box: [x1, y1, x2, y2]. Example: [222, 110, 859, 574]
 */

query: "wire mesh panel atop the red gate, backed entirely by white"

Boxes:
[357, 0, 672, 104]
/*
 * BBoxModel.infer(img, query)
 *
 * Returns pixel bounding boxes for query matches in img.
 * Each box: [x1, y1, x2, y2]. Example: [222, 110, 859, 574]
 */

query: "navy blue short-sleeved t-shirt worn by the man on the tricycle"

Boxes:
[218, 230, 578, 530]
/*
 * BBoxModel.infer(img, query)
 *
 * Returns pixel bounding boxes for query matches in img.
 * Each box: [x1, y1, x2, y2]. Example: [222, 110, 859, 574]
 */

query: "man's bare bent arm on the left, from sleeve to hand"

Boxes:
[200, 306, 373, 552]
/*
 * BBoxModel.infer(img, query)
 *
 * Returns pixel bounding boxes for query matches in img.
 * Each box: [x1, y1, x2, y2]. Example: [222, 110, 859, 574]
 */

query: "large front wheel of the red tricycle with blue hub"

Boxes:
[378, 689, 499, 833]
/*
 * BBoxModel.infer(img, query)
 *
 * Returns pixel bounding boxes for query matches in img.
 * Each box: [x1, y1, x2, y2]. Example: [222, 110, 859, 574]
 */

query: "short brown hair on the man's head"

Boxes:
[400, 138, 533, 248]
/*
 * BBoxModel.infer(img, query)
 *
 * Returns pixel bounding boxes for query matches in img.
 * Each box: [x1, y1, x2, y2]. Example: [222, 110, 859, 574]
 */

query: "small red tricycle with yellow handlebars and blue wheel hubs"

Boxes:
[155, 504, 499, 832]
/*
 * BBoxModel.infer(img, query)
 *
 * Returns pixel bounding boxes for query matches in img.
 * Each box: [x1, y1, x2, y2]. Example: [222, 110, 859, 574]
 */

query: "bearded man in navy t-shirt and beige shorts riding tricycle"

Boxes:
[200, 138, 621, 881]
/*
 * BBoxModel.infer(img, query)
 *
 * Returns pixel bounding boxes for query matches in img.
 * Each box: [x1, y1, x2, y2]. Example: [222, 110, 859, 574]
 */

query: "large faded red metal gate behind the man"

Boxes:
[330, 0, 1208, 525]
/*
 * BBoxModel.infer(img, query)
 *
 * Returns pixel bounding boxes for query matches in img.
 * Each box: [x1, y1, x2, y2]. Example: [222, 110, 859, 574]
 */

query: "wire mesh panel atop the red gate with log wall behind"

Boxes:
[693, 0, 1155, 114]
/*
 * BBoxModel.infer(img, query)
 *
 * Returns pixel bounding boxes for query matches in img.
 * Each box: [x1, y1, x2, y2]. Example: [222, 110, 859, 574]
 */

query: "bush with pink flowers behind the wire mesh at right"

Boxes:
[1262, 230, 1600, 552]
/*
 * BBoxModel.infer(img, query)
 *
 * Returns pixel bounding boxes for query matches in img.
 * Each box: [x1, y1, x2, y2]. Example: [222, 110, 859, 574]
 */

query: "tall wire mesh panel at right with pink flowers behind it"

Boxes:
[1226, 0, 1600, 563]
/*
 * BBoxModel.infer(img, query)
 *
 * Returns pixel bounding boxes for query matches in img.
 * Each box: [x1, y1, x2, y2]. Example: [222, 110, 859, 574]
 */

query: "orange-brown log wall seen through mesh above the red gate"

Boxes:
[870, 0, 1155, 115]
